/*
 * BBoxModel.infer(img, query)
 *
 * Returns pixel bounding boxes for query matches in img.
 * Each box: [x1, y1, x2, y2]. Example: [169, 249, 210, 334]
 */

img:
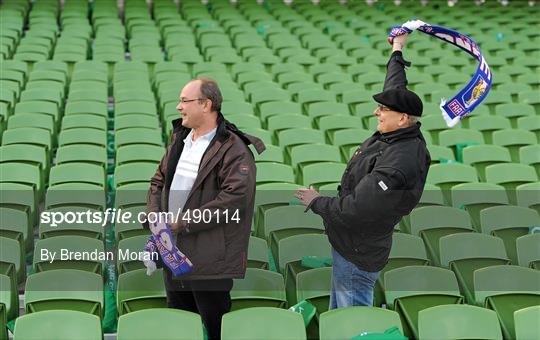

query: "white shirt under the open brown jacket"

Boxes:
[169, 129, 216, 216]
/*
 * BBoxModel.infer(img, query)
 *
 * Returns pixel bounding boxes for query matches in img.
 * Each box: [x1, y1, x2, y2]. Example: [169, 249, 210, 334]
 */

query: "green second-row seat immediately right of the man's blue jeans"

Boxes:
[384, 266, 463, 338]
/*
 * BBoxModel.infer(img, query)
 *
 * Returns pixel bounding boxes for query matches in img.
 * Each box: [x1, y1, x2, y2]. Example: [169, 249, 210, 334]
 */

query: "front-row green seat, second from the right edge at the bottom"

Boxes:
[418, 305, 502, 340]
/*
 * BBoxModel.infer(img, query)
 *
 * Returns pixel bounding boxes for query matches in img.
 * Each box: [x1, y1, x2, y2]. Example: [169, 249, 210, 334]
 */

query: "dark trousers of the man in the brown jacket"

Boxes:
[166, 279, 233, 340]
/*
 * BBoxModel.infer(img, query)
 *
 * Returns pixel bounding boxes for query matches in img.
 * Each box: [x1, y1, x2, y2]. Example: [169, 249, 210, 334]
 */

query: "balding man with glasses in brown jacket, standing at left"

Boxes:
[147, 78, 264, 339]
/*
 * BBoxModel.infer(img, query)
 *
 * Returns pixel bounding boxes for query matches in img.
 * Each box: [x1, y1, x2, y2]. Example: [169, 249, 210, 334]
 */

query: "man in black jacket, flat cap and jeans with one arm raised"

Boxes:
[296, 35, 430, 309]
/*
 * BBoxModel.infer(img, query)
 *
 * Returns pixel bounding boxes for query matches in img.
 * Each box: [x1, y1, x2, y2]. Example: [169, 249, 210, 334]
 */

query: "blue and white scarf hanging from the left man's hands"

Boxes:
[143, 222, 193, 276]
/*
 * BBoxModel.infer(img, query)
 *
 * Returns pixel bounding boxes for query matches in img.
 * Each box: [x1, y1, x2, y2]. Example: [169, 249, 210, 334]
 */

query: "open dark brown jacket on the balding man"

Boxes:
[147, 114, 265, 280]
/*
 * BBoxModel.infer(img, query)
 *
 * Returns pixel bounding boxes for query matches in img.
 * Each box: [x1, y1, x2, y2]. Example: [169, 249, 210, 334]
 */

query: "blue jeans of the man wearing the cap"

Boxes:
[329, 249, 379, 309]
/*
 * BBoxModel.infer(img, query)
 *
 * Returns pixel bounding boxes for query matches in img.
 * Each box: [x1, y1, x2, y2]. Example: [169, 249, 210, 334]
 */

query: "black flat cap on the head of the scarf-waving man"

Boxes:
[373, 89, 424, 117]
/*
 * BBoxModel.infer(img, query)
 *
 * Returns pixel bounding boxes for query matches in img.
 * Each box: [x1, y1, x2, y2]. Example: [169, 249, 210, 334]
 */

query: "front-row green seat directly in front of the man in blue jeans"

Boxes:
[319, 306, 403, 340]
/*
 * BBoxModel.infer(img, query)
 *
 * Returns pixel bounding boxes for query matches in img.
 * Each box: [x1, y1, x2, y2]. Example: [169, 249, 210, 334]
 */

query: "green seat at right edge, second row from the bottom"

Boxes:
[474, 265, 540, 339]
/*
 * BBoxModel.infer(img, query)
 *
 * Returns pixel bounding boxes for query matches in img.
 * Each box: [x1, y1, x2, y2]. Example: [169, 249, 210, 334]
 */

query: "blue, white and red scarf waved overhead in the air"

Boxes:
[388, 19, 493, 127]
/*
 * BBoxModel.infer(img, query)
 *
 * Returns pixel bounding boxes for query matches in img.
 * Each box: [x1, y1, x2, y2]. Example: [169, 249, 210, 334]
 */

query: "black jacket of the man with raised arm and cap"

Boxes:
[310, 52, 431, 272]
